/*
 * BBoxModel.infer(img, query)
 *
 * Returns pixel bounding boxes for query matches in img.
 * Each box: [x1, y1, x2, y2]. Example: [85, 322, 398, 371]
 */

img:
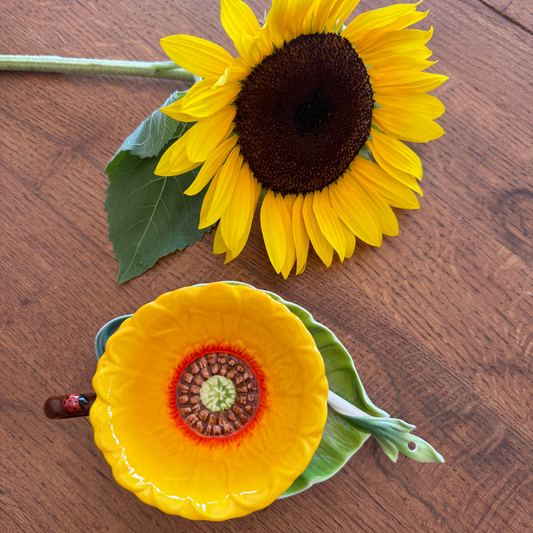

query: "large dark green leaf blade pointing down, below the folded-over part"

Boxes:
[105, 139, 211, 284]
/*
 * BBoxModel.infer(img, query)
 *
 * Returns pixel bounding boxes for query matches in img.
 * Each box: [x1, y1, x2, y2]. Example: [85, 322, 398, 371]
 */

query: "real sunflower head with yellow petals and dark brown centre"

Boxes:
[156, 0, 447, 278]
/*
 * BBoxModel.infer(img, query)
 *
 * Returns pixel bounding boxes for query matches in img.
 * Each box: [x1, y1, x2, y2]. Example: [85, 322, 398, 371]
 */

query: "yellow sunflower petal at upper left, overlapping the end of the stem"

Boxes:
[159, 35, 233, 78]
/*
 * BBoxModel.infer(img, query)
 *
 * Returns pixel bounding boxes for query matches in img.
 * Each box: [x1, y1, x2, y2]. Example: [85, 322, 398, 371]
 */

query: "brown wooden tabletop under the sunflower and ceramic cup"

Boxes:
[0, 0, 533, 533]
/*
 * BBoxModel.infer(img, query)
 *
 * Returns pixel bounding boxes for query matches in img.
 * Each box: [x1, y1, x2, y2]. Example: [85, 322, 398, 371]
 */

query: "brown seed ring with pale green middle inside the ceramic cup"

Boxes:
[176, 352, 259, 437]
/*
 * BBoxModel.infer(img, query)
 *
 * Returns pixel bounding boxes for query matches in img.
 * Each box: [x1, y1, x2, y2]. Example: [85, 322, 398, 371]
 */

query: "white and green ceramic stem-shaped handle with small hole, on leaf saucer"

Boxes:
[328, 391, 444, 463]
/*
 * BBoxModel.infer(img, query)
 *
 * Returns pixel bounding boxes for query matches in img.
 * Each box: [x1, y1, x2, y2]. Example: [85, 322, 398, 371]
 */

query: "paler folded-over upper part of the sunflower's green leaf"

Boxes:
[105, 91, 187, 162]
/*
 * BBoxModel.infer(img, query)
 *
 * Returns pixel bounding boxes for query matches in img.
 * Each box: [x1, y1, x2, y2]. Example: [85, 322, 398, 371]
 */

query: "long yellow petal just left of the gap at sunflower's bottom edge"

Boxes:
[219, 163, 257, 250]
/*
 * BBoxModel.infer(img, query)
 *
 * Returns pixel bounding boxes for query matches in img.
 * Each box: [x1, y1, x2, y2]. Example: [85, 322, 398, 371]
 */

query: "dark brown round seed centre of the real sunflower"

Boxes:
[235, 33, 374, 194]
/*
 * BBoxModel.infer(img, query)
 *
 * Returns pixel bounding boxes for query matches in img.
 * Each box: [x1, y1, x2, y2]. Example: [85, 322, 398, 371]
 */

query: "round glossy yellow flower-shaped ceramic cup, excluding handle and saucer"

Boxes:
[90, 283, 328, 520]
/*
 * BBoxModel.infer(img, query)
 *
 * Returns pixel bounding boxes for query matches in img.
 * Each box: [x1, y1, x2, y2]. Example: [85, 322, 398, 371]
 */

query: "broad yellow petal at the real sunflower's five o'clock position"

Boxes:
[330, 177, 382, 246]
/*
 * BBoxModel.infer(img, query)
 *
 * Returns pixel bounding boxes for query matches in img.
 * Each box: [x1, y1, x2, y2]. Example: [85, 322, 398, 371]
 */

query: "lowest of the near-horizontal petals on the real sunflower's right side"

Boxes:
[373, 108, 444, 142]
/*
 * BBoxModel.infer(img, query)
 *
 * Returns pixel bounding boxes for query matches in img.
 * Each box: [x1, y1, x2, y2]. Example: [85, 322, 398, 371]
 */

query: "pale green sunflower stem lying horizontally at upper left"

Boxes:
[0, 55, 198, 83]
